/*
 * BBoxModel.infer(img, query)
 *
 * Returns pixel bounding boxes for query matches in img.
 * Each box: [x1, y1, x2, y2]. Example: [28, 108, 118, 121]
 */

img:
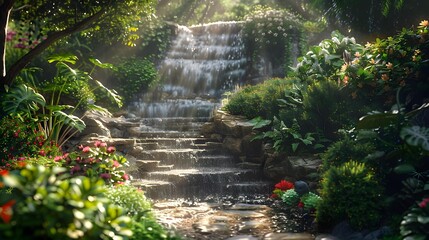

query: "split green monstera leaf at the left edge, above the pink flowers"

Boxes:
[2, 84, 46, 114]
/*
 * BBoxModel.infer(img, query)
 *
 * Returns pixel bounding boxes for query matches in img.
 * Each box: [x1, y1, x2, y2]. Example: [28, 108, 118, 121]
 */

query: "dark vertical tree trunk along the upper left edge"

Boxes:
[0, 0, 15, 92]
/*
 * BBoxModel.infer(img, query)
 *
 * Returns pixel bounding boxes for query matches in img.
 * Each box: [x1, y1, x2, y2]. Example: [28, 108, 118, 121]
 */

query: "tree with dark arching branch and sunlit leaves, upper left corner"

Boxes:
[0, 0, 156, 91]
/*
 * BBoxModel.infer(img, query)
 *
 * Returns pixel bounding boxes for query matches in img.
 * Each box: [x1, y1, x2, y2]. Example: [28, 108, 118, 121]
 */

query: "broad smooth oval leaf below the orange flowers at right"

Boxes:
[356, 113, 398, 129]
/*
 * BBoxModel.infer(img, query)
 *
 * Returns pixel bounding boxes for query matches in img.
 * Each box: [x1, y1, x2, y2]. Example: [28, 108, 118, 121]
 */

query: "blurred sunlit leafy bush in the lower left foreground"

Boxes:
[0, 165, 132, 240]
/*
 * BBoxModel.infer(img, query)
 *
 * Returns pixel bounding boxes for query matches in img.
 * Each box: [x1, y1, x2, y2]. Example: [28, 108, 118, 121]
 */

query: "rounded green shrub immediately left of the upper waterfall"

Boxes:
[116, 58, 158, 102]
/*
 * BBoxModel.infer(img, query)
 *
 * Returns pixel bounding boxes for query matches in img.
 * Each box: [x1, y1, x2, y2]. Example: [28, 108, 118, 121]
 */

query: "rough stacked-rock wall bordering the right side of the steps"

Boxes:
[202, 110, 321, 182]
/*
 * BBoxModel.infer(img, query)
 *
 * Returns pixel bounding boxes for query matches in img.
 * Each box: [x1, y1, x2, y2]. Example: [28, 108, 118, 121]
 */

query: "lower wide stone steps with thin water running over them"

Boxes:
[126, 117, 272, 199]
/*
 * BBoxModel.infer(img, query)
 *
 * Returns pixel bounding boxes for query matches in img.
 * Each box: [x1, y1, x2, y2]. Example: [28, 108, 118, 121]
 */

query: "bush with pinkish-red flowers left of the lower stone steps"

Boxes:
[61, 141, 130, 184]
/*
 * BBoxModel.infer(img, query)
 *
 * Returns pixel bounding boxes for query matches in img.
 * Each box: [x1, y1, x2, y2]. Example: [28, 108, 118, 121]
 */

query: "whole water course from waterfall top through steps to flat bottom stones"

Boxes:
[129, 22, 300, 239]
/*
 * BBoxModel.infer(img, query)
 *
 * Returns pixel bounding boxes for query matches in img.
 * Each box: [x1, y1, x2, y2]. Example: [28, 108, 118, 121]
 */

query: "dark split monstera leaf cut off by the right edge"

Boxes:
[400, 126, 429, 151]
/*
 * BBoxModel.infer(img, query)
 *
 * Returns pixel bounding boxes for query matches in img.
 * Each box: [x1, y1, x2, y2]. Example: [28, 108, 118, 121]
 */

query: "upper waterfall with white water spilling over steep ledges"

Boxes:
[131, 22, 246, 118]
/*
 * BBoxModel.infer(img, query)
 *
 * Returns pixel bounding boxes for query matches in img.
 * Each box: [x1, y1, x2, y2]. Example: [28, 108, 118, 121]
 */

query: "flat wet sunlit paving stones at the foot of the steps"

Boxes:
[153, 197, 314, 240]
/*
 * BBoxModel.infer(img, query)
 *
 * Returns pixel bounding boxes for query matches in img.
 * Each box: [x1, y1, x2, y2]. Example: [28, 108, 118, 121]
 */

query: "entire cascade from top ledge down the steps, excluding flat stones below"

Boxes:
[130, 22, 269, 199]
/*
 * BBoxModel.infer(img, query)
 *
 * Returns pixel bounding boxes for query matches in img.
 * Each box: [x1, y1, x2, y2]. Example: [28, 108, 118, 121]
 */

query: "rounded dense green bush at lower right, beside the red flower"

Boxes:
[317, 161, 383, 229]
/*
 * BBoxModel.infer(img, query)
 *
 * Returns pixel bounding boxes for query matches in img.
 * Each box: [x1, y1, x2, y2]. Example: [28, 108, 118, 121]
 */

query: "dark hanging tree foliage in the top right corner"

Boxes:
[309, 0, 429, 40]
